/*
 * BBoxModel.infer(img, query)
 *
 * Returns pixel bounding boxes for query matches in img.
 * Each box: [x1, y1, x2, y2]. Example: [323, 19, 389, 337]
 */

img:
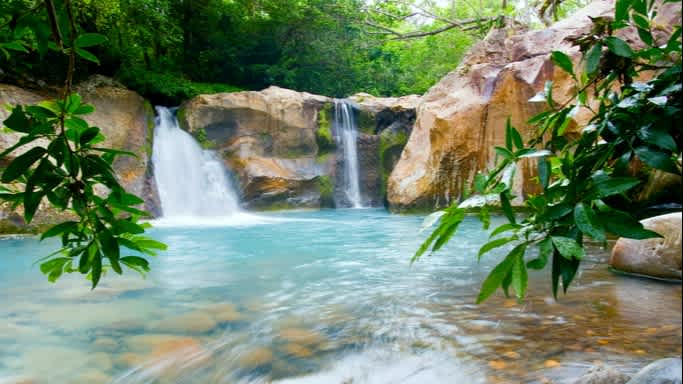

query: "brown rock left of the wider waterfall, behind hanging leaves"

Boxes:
[0, 76, 158, 232]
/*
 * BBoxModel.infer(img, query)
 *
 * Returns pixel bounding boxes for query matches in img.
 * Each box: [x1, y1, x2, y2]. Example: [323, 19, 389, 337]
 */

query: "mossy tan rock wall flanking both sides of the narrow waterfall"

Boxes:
[178, 87, 416, 209]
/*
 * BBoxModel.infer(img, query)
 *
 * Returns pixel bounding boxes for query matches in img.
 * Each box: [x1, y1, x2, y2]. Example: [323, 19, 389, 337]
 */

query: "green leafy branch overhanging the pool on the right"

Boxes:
[413, 0, 683, 302]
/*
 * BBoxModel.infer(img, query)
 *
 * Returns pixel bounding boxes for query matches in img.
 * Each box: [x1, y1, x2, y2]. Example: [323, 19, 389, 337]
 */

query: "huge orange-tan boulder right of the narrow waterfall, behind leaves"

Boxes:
[388, 1, 680, 210]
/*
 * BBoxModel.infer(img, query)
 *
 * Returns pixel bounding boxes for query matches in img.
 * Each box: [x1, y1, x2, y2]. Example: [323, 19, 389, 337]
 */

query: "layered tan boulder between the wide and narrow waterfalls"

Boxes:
[178, 87, 334, 209]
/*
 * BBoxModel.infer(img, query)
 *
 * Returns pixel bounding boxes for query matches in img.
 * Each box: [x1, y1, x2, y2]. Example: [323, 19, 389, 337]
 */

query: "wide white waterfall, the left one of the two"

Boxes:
[152, 107, 239, 218]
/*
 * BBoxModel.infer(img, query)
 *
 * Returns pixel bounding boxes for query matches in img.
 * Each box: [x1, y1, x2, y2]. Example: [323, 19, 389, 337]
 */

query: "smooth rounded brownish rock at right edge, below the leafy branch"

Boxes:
[609, 212, 683, 280]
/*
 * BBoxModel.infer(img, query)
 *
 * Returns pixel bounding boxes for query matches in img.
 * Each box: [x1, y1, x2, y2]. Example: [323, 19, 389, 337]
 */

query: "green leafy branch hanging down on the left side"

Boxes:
[0, 0, 166, 288]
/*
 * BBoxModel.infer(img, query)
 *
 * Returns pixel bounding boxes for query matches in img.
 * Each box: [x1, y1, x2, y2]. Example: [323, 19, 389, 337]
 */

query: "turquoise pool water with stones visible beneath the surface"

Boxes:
[0, 210, 681, 384]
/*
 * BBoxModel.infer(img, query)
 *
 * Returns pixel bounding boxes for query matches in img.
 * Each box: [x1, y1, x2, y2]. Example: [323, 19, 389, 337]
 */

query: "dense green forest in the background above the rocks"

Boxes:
[0, 0, 574, 104]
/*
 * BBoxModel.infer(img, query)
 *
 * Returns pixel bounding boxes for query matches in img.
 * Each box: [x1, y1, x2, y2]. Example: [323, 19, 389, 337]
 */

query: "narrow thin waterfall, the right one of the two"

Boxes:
[334, 100, 363, 208]
